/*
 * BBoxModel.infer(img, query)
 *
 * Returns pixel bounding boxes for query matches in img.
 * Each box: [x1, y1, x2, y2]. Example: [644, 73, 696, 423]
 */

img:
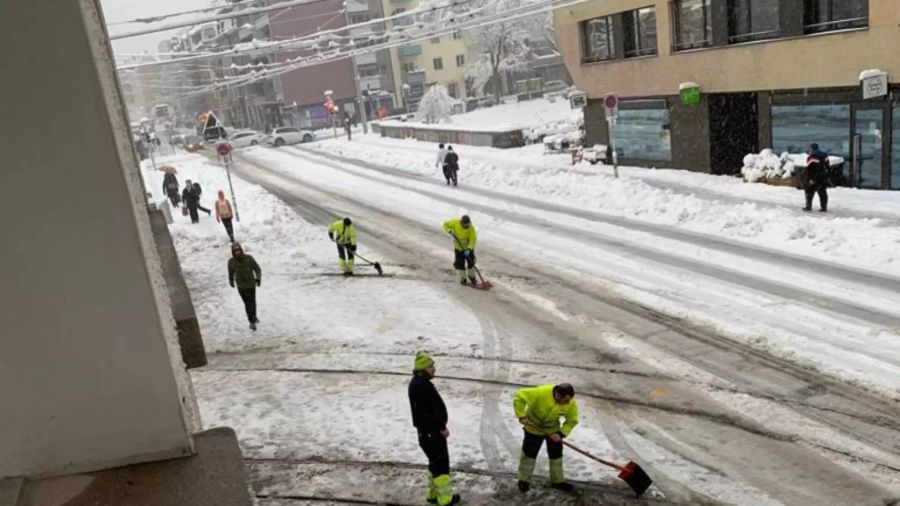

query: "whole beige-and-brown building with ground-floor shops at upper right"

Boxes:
[554, 0, 900, 189]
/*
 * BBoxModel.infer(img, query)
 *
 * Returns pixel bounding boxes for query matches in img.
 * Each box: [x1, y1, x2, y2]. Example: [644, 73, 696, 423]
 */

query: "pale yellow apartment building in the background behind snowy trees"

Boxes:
[381, 0, 468, 111]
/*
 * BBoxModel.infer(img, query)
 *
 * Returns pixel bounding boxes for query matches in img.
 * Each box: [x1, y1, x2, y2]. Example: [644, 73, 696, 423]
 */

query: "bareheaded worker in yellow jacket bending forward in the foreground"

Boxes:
[513, 383, 578, 494]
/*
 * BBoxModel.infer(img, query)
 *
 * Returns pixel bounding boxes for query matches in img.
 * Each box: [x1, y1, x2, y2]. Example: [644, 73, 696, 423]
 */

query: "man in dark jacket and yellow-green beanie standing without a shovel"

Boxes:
[409, 352, 460, 506]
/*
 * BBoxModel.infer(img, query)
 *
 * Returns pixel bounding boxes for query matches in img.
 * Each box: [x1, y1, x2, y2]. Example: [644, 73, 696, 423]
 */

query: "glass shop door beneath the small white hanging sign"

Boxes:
[851, 105, 889, 188]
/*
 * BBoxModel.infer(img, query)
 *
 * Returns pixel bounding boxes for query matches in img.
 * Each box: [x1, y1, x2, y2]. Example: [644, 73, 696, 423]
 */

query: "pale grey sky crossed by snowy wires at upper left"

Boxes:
[100, 0, 213, 54]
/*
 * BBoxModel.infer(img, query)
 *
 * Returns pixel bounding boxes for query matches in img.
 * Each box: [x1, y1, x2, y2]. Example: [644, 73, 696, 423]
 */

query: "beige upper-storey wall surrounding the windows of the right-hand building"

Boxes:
[554, 0, 900, 98]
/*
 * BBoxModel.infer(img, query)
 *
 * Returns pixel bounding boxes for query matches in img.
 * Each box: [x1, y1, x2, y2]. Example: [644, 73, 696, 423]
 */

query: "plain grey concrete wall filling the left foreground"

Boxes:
[0, 0, 198, 478]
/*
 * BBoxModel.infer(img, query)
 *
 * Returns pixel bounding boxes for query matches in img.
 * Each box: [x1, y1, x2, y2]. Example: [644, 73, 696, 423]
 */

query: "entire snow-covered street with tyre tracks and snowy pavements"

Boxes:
[148, 136, 900, 505]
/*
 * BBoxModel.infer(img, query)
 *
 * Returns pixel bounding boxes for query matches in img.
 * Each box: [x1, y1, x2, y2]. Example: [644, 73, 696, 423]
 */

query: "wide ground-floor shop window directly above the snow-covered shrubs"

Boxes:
[772, 104, 850, 160]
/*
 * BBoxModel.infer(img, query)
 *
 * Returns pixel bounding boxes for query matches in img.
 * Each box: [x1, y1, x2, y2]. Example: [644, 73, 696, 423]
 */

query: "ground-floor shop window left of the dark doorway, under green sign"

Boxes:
[613, 104, 672, 161]
